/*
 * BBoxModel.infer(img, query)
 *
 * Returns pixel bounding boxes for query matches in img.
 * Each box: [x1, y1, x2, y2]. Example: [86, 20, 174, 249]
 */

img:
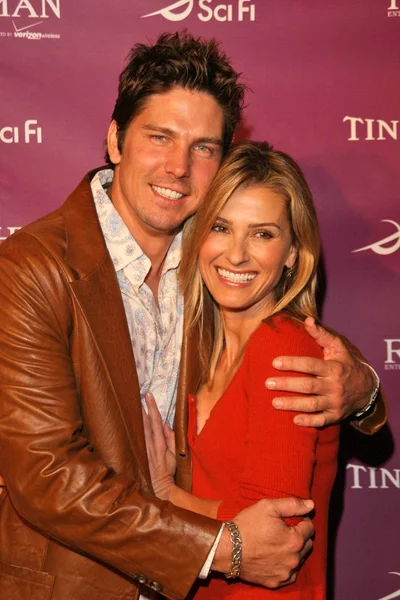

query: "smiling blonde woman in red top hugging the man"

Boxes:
[144, 143, 338, 600]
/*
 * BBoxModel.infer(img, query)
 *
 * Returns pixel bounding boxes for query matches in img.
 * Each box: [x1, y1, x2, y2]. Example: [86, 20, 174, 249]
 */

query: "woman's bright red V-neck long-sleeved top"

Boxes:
[188, 317, 339, 600]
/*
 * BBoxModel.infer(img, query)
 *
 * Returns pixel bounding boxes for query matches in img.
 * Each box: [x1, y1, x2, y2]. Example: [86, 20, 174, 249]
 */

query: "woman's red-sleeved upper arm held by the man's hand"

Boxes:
[217, 320, 338, 519]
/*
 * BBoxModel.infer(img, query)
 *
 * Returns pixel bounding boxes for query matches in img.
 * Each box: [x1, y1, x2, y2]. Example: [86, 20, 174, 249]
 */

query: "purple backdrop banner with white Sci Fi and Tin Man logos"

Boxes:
[0, 0, 400, 600]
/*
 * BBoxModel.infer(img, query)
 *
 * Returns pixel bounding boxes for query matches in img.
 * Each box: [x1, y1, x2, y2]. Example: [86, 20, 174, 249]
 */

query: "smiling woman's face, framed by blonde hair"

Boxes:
[199, 185, 296, 318]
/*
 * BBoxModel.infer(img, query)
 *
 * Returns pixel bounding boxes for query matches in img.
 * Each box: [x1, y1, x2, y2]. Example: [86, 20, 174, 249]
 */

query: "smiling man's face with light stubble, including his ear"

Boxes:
[108, 86, 223, 235]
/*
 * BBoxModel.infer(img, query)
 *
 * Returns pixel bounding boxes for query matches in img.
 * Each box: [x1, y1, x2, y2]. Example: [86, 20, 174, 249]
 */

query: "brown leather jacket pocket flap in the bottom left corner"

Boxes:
[0, 560, 55, 600]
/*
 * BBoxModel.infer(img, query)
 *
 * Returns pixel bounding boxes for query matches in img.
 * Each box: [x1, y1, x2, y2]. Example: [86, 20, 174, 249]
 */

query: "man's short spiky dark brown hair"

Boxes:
[106, 32, 245, 165]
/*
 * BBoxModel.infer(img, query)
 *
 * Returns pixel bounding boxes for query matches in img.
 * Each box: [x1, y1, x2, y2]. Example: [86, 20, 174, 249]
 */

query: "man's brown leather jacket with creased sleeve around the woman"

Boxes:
[0, 171, 219, 600]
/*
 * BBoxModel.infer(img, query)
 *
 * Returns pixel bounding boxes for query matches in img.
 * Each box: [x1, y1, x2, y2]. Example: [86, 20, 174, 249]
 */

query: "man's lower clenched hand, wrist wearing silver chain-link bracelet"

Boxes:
[212, 498, 314, 589]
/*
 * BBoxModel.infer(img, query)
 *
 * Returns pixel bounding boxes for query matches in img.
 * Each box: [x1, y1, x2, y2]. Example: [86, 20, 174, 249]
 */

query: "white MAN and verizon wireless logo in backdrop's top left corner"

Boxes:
[0, 0, 61, 40]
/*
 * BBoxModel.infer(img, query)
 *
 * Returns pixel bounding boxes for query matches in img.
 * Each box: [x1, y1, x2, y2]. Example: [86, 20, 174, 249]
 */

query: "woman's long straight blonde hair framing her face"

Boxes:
[179, 142, 320, 383]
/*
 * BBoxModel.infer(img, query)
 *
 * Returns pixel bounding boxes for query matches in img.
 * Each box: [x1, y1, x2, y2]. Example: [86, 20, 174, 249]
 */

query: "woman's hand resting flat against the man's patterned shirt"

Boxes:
[142, 392, 176, 500]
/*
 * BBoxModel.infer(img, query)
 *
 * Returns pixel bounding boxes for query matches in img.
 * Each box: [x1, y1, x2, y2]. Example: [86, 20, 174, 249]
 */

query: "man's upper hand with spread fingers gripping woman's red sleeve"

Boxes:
[265, 317, 374, 427]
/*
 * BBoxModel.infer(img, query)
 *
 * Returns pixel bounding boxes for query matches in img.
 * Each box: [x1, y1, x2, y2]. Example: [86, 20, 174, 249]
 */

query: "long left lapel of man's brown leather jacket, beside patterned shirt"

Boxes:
[62, 173, 150, 482]
